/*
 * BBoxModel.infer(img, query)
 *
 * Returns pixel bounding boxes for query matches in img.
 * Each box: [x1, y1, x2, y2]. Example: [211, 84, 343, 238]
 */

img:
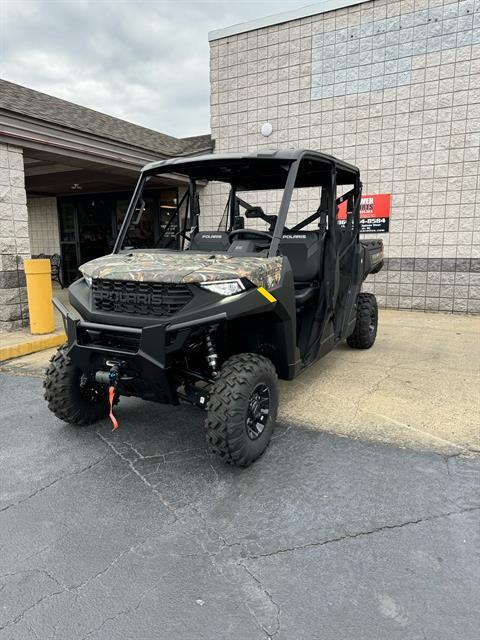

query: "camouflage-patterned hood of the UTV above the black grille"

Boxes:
[80, 251, 282, 289]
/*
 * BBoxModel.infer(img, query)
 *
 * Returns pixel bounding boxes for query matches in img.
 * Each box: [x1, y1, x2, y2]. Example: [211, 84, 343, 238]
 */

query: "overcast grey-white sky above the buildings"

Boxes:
[0, 0, 312, 137]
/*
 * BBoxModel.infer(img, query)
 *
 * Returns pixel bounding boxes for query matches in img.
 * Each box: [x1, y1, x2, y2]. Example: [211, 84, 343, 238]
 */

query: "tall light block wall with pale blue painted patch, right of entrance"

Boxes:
[204, 0, 480, 313]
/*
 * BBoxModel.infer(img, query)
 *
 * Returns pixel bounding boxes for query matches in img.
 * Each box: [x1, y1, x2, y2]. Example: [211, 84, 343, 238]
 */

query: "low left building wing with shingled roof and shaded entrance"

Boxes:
[0, 80, 212, 331]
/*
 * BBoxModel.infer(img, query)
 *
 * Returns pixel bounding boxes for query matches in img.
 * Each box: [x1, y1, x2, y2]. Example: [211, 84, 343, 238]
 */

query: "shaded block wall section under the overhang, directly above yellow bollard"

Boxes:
[27, 197, 60, 255]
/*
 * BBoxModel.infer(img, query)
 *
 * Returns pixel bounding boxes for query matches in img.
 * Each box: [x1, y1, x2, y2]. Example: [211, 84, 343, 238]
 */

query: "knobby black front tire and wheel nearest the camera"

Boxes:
[205, 353, 278, 467]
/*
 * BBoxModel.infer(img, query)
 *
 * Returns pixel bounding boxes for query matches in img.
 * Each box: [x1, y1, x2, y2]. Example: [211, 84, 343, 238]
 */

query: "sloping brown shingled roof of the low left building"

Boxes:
[0, 80, 213, 157]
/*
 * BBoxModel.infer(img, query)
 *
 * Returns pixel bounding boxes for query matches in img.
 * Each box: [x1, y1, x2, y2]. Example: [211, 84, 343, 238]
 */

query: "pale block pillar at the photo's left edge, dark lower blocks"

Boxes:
[0, 144, 30, 332]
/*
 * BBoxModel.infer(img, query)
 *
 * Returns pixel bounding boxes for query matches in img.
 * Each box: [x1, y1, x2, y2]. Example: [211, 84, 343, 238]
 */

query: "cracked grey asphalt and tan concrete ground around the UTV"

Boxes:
[0, 312, 480, 640]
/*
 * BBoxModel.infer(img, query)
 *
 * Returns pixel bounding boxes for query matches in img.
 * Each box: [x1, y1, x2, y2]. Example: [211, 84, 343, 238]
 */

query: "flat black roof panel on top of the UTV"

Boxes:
[143, 149, 360, 189]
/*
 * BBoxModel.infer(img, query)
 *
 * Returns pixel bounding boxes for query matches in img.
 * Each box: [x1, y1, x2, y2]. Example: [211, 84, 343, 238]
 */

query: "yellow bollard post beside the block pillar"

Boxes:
[23, 258, 55, 333]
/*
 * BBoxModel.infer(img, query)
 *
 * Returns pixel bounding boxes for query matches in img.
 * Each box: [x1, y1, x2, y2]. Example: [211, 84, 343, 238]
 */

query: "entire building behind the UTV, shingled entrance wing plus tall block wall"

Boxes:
[0, 0, 480, 331]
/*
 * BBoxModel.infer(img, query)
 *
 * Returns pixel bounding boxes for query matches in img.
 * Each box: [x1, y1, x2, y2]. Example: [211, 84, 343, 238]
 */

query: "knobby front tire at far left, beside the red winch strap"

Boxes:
[43, 345, 113, 427]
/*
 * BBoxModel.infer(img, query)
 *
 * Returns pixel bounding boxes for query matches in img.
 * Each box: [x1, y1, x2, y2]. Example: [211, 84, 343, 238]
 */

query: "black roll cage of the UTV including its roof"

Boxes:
[113, 149, 362, 257]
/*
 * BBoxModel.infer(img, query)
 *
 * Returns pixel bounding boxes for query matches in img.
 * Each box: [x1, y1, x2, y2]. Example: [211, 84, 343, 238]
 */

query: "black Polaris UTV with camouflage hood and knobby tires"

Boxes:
[44, 150, 383, 467]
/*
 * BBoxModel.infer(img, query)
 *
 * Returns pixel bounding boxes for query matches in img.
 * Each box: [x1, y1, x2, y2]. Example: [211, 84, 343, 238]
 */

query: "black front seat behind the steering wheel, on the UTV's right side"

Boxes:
[280, 231, 321, 307]
